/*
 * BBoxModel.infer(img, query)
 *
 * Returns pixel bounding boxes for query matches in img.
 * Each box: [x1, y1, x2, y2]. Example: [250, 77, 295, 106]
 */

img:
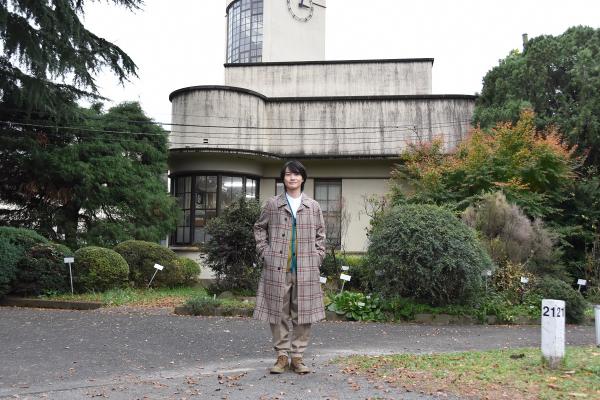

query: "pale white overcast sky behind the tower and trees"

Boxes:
[84, 0, 600, 123]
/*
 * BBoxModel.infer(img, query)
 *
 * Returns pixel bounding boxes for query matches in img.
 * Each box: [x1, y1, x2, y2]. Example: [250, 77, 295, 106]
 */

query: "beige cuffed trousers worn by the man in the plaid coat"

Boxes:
[270, 272, 311, 357]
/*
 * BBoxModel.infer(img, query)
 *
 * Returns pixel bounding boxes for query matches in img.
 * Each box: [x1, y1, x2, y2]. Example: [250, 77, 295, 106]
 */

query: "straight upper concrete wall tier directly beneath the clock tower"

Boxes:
[225, 59, 433, 97]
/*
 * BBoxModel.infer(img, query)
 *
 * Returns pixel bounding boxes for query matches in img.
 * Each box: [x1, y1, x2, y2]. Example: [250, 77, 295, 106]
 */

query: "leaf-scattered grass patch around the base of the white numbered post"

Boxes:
[337, 346, 600, 400]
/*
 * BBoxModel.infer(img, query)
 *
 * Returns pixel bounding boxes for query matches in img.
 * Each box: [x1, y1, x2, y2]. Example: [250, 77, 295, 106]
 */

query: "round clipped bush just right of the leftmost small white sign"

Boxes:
[73, 246, 129, 292]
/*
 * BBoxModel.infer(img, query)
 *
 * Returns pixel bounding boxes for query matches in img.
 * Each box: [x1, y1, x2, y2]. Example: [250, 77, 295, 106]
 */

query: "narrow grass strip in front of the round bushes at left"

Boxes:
[42, 287, 206, 307]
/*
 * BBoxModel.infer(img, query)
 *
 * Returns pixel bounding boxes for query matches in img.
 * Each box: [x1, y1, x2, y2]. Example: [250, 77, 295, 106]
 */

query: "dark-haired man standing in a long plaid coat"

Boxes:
[254, 161, 325, 374]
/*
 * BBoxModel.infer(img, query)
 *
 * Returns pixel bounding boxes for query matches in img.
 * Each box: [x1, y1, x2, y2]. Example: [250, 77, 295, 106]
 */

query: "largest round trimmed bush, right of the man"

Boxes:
[367, 204, 492, 306]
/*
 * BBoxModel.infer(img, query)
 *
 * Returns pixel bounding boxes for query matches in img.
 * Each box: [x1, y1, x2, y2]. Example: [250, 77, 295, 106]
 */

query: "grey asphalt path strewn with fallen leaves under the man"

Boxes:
[0, 307, 594, 399]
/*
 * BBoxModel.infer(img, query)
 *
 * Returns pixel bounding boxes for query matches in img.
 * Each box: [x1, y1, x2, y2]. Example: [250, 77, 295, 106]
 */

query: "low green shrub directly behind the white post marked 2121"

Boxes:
[535, 276, 587, 324]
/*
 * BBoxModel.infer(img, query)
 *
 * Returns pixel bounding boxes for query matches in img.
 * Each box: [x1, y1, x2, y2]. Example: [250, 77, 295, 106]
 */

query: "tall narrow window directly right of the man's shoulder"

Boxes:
[315, 180, 342, 248]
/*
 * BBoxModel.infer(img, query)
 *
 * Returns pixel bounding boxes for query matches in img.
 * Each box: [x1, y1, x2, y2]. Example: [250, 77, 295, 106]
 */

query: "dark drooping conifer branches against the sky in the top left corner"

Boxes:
[0, 0, 142, 109]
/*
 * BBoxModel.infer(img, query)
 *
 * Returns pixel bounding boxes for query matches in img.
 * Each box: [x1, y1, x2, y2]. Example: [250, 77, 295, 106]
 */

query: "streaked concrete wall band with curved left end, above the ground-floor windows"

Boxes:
[170, 86, 475, 157]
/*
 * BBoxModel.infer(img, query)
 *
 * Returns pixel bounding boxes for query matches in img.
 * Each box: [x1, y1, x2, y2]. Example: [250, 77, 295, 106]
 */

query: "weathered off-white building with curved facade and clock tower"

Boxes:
[169, 0, 475, 276]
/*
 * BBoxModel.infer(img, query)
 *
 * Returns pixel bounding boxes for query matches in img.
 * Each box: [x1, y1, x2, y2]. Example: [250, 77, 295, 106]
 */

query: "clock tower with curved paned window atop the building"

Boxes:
[226, 0, 326, 64]
